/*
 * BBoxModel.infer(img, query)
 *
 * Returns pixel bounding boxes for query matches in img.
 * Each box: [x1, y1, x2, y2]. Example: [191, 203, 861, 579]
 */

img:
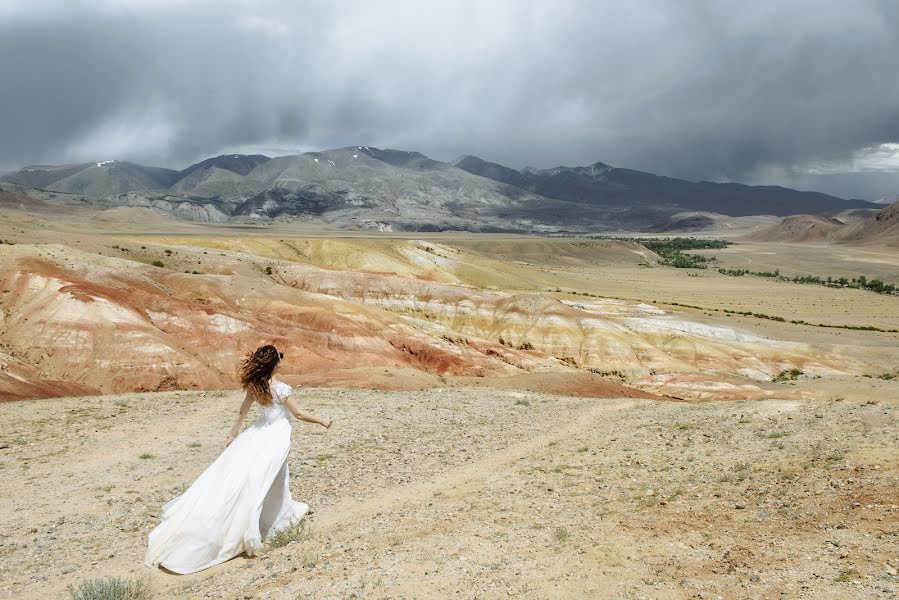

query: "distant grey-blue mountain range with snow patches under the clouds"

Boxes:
[0, 146, 882, 232]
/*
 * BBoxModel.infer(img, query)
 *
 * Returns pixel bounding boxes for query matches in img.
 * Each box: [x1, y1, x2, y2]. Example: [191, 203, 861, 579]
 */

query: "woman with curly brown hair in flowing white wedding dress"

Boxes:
[144, 345, 332, 574]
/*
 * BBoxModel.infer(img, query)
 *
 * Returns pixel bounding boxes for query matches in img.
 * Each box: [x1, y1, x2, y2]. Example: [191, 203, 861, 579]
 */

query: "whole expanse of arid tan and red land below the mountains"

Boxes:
[0, 205, 899, 599]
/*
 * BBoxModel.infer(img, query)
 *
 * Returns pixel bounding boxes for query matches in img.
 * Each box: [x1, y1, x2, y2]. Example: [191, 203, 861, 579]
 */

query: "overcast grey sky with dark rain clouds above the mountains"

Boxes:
[0, 0, 899, 199]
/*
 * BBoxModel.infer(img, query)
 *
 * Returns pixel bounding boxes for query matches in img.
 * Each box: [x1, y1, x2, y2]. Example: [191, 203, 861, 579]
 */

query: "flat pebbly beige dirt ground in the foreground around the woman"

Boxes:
[0, 381, 899, 599]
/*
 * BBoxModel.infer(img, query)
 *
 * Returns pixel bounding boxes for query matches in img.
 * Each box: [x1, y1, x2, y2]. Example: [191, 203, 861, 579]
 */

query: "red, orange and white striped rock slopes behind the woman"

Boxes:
[0, 244, 845, 399]
